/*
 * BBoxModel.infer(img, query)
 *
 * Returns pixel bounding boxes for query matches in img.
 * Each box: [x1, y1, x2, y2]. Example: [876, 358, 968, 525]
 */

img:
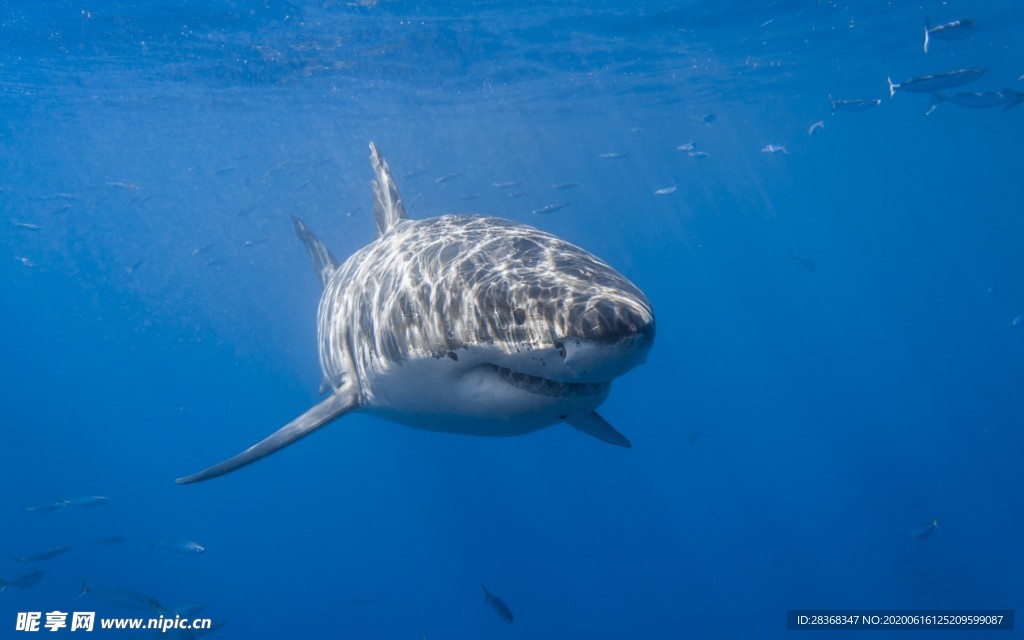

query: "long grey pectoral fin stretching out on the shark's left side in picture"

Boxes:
[174, 384, 357, 484]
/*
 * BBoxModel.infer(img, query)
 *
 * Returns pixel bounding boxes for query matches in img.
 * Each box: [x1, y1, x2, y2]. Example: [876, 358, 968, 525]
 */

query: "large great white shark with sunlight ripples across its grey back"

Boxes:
[177, 143, 654, 483]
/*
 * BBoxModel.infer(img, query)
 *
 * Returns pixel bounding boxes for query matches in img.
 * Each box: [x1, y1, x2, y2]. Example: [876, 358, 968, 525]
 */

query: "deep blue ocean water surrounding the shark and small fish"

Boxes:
[0, 0, 1024, 640]
